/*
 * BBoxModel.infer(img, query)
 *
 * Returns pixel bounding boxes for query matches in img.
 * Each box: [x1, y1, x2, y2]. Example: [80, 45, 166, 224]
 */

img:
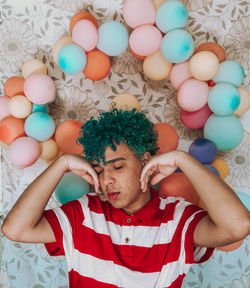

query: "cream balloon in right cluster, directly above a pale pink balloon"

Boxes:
[189, 51, 220, 81]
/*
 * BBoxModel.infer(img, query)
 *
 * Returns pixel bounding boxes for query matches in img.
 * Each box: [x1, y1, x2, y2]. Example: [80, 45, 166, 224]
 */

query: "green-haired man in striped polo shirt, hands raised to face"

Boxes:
[2, 109, 250, 288]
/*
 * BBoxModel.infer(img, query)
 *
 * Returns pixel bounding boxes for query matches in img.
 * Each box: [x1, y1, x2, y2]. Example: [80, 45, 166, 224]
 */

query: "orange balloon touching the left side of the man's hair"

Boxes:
[55, 120, 83, 155]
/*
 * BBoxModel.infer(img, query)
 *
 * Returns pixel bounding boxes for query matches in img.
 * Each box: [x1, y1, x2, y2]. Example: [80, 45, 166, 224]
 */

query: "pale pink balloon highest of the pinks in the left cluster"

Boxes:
[24, 74, 56, 105]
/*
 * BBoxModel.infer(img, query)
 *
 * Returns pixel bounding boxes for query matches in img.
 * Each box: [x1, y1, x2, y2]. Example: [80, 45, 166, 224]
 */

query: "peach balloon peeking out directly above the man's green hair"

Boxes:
[110, 93, 140, 111]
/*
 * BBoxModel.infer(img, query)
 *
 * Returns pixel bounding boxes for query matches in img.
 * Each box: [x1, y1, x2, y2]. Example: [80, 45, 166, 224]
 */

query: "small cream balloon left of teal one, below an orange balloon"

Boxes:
[9, 95, 32, 118]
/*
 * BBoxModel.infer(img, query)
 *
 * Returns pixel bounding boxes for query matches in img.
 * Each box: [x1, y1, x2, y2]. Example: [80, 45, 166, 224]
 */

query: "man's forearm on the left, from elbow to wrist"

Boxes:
[2, 157, 67, 235]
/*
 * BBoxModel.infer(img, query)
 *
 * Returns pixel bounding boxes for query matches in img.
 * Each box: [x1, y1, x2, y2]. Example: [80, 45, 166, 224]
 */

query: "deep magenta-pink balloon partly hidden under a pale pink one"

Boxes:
[181, 104, 213, 129]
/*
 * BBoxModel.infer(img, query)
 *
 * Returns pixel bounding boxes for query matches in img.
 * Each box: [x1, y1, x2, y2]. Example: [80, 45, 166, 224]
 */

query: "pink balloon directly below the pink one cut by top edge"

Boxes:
[129, 24, 162, 56]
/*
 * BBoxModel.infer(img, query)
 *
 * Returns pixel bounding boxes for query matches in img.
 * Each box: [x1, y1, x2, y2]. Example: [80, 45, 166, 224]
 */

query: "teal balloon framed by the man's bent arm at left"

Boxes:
[54, 172, 89, 204]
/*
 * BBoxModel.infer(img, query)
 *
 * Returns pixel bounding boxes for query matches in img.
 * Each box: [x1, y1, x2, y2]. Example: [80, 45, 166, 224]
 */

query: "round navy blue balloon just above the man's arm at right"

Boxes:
[188, 138, 217, 164]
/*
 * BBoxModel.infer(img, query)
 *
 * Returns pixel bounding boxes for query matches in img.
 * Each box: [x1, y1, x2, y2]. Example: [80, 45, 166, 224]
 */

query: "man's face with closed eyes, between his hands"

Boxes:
[93, 143, 151, 214]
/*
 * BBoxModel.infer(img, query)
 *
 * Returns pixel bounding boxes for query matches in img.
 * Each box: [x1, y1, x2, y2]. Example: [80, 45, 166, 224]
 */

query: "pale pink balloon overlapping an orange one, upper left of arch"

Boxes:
[72, 19, 99, 52]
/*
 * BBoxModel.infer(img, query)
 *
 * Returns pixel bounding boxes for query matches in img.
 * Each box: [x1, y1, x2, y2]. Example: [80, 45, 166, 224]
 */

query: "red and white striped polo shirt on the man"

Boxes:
[44, 190, 213, 288]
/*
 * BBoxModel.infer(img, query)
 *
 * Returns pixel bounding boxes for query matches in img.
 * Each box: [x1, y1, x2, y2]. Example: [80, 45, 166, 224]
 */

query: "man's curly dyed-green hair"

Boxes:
[77, 108, 159, 164]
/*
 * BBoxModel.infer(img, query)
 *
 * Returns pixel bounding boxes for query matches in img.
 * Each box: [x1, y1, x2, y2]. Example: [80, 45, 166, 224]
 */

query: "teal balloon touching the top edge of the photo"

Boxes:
[155, 1, 188, 33]
